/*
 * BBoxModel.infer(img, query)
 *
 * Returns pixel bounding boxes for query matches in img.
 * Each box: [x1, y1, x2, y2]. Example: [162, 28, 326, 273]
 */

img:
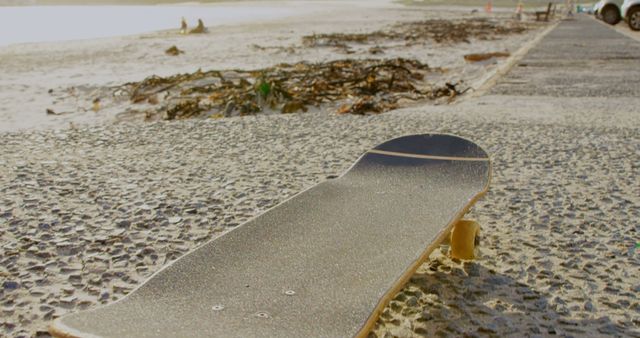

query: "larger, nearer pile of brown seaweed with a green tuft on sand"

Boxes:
[118, 58, 462, 120]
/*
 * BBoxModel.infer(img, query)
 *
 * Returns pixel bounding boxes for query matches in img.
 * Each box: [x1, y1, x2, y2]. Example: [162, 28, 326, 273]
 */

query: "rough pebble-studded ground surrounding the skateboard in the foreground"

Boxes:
[0, 106, 640, 337]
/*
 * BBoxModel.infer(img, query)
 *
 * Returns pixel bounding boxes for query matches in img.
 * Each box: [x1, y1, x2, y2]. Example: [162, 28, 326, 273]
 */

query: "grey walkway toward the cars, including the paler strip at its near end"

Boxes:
[420, 15, 640, 128]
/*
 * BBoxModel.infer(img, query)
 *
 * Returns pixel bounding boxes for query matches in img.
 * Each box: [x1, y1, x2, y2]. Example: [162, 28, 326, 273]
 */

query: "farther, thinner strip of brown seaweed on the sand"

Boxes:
[302, 18, 531, 48]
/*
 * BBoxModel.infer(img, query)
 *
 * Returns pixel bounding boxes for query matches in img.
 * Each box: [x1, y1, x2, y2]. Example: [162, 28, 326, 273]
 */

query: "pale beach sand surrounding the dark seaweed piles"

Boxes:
[0, 1, 537, 131]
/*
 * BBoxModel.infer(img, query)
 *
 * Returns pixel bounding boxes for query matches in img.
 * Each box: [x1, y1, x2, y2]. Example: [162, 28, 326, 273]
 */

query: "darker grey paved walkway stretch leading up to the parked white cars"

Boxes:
[490, 15, 640, 97]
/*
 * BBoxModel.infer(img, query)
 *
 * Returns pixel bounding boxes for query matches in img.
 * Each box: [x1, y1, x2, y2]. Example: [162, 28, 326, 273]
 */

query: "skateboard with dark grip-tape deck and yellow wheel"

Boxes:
[50, 134, 491, 337]
